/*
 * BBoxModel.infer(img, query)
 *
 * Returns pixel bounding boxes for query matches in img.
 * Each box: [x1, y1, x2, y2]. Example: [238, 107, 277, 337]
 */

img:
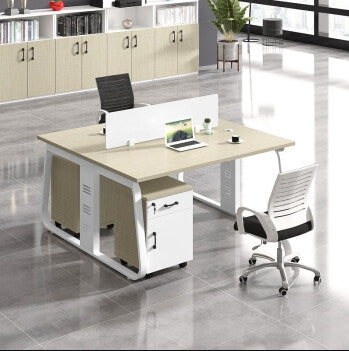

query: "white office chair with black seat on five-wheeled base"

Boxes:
[234, 165, 321, 295]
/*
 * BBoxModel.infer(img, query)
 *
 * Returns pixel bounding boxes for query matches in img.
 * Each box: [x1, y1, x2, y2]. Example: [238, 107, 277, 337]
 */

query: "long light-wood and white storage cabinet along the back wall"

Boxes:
[0, 0, 199, 103]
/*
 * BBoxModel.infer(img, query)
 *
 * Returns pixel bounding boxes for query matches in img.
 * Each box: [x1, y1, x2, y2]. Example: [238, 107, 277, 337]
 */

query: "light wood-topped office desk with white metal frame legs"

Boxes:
[38, 120, 294, 280]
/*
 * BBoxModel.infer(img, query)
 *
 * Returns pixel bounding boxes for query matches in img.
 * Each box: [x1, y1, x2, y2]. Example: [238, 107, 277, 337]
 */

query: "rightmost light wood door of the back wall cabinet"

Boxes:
[178, 24, 199, 74]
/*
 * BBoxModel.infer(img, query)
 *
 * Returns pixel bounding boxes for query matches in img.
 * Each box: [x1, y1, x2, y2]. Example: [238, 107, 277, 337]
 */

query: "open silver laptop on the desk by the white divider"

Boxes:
[165, 118, 207, 151]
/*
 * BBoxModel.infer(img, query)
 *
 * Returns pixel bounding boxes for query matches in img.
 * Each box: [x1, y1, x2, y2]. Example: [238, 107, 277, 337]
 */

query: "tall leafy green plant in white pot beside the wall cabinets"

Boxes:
[207, 0, 251, 61]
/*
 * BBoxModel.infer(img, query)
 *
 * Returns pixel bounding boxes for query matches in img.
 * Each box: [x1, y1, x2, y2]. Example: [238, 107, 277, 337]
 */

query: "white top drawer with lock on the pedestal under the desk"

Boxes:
[146, 191, 193, 220]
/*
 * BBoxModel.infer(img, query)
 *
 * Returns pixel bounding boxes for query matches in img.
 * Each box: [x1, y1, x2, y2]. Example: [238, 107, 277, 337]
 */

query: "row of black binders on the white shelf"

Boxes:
[57, 12, 102, 37]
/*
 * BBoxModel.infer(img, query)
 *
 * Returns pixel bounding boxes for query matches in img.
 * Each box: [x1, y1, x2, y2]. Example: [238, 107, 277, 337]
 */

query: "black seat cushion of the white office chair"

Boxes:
[234, 212, 313, 241]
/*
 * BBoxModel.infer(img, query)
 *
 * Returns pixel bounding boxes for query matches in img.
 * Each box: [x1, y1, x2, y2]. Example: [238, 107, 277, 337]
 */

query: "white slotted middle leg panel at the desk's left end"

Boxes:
[80, 165, 100, 255]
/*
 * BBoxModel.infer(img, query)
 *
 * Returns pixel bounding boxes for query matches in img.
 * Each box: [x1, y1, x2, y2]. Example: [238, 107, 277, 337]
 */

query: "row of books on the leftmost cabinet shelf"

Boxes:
[0, 19, 40, 44]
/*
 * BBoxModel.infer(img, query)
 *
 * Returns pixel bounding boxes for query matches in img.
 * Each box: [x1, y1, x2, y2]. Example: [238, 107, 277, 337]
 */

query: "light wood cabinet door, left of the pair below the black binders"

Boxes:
[56, 37, 81, 93]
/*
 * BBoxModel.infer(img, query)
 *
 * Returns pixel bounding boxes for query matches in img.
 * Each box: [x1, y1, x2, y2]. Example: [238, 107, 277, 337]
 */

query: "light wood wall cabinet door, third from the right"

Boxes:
[132, 29, 155, 82]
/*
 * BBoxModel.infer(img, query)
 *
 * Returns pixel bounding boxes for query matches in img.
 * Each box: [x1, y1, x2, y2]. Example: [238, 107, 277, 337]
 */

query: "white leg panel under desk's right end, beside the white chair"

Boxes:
[221, 160, 241, 215]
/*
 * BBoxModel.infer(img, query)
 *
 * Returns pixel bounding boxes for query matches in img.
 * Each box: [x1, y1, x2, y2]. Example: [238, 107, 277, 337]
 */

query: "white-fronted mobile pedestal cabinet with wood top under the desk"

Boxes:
[114, 177, 193, 274]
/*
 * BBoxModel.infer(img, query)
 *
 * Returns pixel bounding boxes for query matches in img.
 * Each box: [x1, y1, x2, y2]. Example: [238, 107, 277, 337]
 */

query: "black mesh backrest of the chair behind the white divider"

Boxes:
[96, 73, 134, 112]
